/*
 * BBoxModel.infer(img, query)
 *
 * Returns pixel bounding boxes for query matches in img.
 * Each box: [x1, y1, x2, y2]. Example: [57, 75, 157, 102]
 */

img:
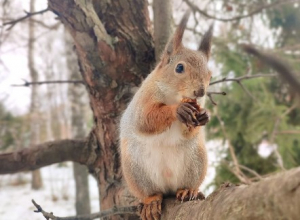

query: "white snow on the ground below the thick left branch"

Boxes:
[0, 163, 99, 220]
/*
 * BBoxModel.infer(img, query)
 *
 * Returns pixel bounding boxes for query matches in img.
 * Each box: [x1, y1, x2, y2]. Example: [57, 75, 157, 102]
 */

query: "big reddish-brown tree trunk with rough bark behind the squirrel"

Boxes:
[49, 0, 154, 219]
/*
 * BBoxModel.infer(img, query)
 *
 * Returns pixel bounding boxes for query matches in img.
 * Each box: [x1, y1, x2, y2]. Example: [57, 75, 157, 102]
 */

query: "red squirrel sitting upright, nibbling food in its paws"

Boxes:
[120, 13, 212, 220]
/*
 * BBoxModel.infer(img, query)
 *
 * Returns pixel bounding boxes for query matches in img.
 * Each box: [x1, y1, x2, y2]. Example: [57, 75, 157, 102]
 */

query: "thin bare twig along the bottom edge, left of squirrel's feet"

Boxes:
[31, 199, 139, 220]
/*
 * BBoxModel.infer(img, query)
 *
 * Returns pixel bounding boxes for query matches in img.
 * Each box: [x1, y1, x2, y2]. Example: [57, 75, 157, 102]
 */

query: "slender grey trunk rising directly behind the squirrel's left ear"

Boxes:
[153, 0, 173, 60]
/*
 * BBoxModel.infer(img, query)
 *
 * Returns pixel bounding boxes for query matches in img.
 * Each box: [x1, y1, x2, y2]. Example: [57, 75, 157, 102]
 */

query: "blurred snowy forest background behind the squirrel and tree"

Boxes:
[0, 0, 300, 219]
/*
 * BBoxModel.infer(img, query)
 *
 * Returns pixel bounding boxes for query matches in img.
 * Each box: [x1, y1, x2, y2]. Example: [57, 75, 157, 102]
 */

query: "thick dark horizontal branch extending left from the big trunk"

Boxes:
[0, 140, 90, 174]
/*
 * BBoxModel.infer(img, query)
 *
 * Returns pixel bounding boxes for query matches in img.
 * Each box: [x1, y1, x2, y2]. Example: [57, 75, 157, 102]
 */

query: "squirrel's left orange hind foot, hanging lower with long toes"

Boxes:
[140, 194, 163, 220]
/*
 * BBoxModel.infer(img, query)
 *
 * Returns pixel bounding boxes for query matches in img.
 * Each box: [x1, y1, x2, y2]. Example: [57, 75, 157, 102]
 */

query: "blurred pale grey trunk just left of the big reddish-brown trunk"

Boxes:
[65, 28, 91, 215]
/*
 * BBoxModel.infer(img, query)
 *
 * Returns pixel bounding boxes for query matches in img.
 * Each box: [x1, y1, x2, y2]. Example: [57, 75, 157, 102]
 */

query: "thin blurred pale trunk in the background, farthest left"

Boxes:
[28, 0, 43, 190]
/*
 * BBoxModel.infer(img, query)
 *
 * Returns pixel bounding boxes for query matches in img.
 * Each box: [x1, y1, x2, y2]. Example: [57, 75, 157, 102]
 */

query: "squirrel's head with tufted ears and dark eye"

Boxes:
[155, 12, 213, 102]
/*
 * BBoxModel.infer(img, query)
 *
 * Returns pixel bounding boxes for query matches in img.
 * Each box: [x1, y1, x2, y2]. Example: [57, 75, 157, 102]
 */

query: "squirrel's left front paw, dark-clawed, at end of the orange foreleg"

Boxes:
[176, 102, 200, 127]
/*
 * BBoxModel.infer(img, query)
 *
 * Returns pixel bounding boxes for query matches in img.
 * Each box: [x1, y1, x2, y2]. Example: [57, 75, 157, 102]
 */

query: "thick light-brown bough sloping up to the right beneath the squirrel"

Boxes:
[162, 168, 300, 220]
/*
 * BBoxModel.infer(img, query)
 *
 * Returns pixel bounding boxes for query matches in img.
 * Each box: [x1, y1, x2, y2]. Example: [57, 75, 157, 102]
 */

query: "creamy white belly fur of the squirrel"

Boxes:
[137, 121, 193, 193]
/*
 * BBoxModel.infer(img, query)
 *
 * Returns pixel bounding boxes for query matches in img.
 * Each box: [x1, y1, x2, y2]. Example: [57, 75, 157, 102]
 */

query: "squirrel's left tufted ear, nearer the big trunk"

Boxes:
[165, 10, 191, 55]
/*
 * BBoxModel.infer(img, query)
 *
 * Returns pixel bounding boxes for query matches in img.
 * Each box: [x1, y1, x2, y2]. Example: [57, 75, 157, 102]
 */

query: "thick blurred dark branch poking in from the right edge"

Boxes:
[242, 45, 300, 95]
